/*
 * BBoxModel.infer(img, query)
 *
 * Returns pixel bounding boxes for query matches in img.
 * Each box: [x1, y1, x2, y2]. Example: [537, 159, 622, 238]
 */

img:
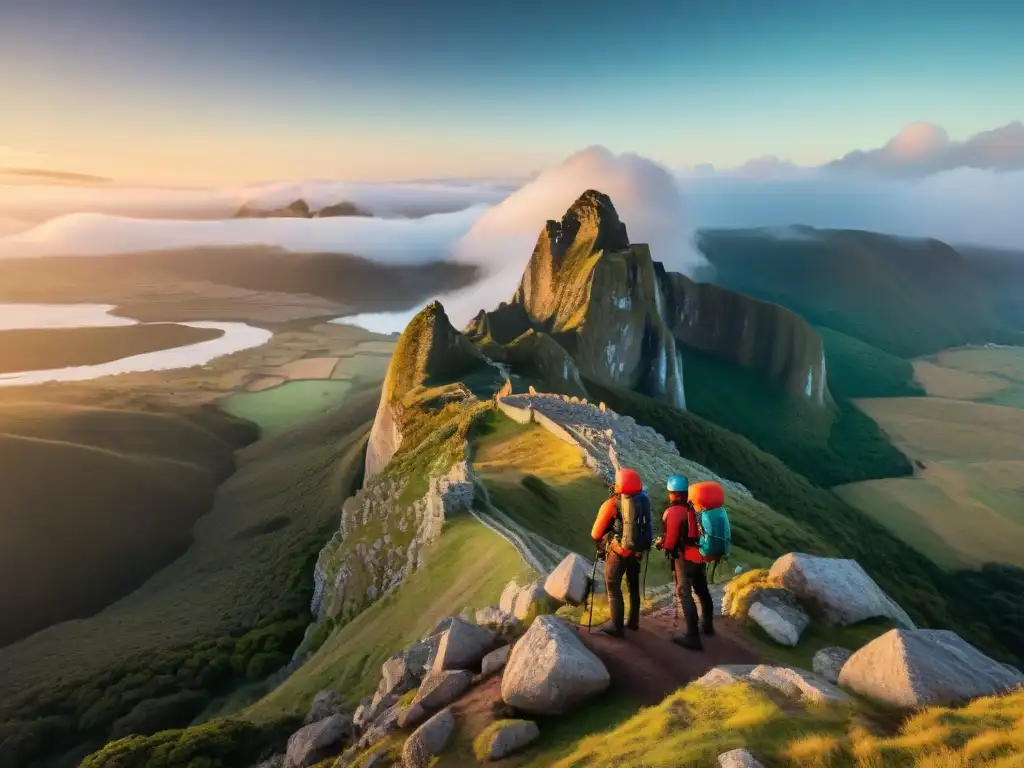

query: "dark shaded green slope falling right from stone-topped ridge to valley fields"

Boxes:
[587, 382, 1024, 659]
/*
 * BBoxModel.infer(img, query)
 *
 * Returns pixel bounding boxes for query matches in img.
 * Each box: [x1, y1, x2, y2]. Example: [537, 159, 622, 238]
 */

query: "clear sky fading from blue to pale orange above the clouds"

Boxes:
[0, 0, 1024, 182]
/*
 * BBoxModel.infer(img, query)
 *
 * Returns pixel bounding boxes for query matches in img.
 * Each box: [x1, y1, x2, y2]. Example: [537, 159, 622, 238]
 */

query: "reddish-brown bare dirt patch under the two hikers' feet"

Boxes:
[580, 606, 764, 705]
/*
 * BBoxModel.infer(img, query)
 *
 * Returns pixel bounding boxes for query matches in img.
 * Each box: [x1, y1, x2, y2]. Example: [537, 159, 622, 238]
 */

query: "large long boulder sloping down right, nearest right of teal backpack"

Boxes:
[769, 552, 914, 630]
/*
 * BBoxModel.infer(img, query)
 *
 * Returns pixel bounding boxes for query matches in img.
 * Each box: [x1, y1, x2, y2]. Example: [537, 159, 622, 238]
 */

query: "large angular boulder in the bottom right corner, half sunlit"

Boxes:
[839, 630, 1024, 709]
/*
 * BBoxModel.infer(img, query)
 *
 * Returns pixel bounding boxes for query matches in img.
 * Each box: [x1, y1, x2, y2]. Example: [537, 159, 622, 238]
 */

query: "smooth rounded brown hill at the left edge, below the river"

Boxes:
[0, 392, 255, 645]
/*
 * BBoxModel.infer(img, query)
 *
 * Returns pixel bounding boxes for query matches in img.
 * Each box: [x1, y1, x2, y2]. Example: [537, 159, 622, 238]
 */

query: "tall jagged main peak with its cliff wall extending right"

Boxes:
[499, 190, 827, 408]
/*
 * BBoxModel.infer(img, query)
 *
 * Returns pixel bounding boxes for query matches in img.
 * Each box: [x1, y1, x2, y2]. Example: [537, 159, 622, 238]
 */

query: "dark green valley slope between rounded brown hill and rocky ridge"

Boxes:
[0, 390, 379, 765]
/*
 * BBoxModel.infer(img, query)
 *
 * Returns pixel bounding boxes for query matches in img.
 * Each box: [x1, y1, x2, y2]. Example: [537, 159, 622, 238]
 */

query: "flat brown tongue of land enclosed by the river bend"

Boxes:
[0, 324, 223, 374]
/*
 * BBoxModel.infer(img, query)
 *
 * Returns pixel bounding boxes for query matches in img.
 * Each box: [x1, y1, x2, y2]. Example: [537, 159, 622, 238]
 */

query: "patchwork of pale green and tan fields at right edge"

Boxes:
[836, 356, 1024, 568]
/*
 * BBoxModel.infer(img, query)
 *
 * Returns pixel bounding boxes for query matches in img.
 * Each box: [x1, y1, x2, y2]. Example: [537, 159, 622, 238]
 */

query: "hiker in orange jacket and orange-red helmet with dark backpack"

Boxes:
[590, 468, 654, 637]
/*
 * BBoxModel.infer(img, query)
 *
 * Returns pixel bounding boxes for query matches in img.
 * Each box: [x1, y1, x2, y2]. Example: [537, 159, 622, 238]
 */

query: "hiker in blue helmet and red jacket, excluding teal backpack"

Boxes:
[654, 475, 721, 650]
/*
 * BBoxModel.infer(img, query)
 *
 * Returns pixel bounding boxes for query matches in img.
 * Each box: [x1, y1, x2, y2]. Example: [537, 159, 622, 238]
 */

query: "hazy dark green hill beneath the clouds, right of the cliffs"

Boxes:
[698, 227, 1021, 357]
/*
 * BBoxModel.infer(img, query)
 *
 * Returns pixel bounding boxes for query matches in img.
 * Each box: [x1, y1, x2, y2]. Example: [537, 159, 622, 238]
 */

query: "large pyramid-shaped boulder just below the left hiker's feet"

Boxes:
[502, 615, 611, 715]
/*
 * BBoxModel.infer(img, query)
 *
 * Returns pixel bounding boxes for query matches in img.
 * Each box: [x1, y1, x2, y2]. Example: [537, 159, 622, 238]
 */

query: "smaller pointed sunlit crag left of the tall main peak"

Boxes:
[366, 301, 488, 479]
